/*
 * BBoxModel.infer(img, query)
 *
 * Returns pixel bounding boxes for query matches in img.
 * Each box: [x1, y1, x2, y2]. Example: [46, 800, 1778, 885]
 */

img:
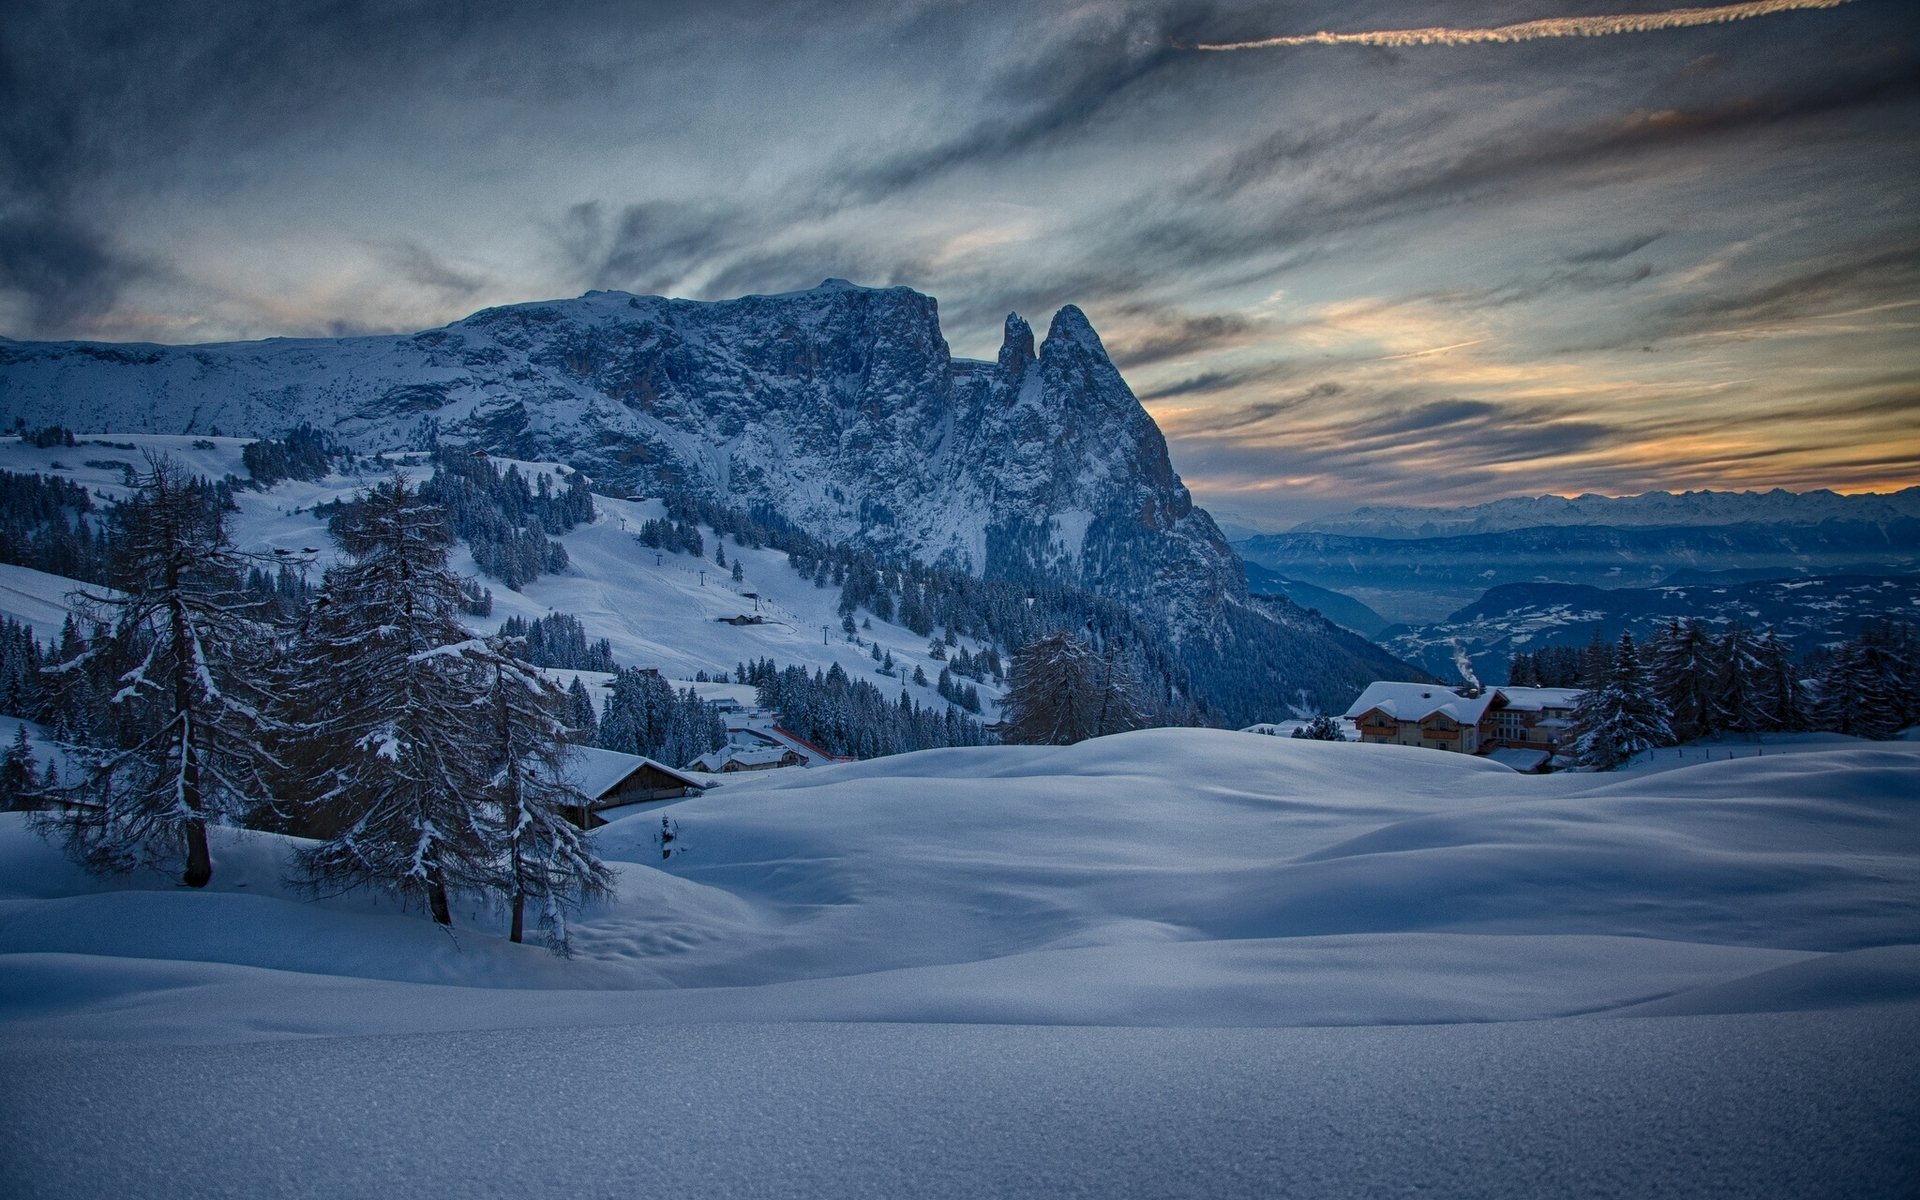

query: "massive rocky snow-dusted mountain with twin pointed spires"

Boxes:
[0, 280, 1405, 720]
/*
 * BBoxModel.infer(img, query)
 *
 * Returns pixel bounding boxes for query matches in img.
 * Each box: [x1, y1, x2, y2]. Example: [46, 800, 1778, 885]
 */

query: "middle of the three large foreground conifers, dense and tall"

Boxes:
[288, 474, 499, 925]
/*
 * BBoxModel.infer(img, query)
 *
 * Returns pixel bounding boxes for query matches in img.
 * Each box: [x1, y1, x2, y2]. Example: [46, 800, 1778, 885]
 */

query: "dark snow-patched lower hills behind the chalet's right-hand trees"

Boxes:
[1379, 574, 1920, 684]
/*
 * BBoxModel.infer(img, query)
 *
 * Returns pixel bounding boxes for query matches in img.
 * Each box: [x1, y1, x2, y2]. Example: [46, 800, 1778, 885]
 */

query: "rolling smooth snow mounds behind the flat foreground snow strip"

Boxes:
[0, 730, 1920, 1041]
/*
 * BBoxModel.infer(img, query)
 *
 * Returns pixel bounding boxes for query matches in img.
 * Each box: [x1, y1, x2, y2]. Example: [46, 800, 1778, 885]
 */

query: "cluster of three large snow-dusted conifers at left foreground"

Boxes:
[11, 457, 611, 948]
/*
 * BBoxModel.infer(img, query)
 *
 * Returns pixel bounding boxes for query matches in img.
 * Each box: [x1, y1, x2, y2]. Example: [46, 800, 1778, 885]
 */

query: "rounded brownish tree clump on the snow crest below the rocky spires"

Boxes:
[1000, 632, 1146, 745]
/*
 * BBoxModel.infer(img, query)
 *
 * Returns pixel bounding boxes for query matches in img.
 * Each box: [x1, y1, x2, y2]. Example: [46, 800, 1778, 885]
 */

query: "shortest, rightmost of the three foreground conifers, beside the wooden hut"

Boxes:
[490, 656, 612, 954]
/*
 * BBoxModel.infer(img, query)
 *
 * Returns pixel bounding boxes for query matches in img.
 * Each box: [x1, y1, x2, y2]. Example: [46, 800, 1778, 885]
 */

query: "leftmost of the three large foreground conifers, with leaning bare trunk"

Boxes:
[42, 455, 275, 887]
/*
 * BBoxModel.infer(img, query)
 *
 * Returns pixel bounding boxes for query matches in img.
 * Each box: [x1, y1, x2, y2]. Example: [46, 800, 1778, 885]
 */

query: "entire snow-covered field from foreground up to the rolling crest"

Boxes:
[0, 730, 1920, 1196]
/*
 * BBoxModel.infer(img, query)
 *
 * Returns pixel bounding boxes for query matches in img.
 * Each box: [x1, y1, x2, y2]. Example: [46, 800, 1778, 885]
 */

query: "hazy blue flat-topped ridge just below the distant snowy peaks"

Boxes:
[1238, 518, 1920, 624]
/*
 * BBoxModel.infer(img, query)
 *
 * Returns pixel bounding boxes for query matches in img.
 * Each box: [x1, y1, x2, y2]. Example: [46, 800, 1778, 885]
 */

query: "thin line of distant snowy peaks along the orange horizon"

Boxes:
[1292, 488, 1920, 538]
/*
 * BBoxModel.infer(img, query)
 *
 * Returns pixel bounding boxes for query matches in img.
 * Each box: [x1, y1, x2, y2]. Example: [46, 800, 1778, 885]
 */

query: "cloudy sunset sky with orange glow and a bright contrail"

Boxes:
[0, 0, 1920, 528]
